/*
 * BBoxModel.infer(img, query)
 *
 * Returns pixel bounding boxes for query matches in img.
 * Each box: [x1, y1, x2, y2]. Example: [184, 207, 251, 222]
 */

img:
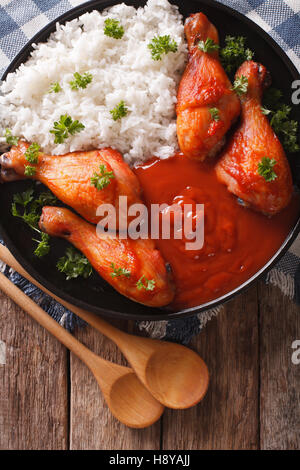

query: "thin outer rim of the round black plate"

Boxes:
[0, 0, 300, 321]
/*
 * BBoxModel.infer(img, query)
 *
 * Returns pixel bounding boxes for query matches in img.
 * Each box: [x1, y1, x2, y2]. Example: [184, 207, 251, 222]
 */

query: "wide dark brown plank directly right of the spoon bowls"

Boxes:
[163, 287, 259, 450]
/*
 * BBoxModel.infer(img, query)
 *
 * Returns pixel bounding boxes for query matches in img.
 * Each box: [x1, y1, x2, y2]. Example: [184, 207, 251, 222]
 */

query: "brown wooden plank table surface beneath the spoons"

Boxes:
[0, 283, 300, 450]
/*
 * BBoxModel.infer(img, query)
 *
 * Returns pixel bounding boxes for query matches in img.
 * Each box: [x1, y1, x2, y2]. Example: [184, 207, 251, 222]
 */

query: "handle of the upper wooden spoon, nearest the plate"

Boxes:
[0, 244, 128, 346]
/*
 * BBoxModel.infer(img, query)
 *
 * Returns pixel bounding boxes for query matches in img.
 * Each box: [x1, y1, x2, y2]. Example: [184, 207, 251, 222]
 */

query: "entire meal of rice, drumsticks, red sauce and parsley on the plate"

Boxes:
[0, 0, 299, 310]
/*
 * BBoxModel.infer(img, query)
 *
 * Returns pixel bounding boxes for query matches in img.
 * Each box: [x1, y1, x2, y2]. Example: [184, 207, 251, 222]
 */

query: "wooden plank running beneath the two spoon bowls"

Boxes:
[70, 322, 160, 450]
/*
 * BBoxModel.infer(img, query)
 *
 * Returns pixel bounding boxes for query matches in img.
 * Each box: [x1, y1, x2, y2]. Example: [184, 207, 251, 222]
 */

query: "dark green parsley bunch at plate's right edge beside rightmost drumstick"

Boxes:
[263, 88, 300, 153]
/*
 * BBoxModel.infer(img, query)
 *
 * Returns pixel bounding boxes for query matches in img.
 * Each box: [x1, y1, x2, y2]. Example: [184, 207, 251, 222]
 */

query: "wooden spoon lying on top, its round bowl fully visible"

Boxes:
[0, 245, 209, 409]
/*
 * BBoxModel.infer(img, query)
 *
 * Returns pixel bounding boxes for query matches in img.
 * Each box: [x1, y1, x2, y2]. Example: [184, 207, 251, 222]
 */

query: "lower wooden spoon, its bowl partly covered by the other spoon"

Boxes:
[0, 273, 164, 428]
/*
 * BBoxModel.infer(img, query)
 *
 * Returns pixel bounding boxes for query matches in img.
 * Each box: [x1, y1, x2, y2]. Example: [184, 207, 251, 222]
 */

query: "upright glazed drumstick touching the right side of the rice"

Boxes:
[176, 13, 240, 161]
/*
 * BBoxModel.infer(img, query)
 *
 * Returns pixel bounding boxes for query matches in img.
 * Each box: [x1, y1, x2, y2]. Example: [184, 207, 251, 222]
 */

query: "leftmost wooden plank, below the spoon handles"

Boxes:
[0, 292, 68, 450]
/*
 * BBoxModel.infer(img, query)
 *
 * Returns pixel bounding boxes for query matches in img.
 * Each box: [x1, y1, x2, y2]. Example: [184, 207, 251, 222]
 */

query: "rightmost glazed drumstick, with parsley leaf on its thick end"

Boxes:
[216, 61, 292, 215]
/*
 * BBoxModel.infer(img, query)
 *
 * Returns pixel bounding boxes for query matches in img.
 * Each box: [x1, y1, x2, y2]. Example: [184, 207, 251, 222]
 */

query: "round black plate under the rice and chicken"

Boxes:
[0, 0, 300, 320]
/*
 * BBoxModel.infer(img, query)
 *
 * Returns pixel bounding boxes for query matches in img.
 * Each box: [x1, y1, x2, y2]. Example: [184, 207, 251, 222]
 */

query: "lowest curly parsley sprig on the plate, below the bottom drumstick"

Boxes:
[56, 247, 93, 281]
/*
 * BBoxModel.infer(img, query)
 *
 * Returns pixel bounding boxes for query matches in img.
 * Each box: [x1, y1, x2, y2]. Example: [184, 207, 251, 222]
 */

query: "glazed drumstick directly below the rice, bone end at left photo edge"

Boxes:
[0, 141, 140, 224]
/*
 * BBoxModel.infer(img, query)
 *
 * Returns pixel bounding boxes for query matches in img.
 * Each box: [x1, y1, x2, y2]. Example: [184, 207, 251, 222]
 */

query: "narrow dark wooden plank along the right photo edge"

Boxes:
[259, 284, 300, 450]
